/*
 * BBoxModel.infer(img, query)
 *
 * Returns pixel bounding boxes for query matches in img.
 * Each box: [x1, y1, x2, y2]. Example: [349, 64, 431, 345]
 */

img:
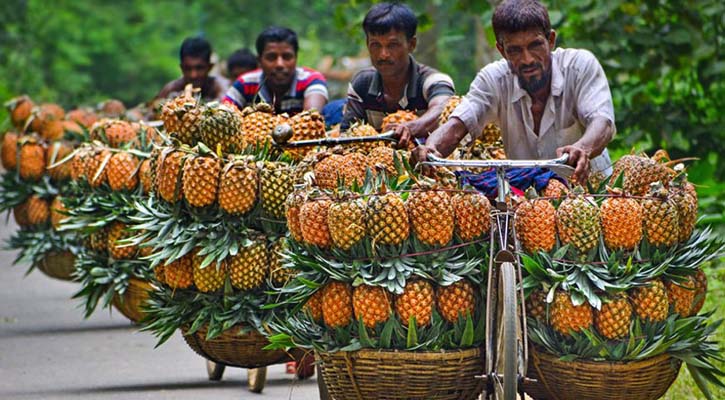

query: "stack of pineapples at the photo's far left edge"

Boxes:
[0, 96, 94, 279]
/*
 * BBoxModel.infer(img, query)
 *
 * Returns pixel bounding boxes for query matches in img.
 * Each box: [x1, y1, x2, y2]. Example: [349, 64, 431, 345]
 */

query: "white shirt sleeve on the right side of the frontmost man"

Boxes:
[575, 51, 616, 131]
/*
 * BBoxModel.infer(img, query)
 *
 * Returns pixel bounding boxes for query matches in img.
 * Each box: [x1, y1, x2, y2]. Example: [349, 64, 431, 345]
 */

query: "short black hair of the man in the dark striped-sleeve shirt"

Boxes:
[363, 2, 418, 39]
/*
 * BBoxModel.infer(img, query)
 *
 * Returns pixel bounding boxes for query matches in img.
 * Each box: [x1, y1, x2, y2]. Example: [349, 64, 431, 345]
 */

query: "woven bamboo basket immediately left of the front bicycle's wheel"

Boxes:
[317, 348, 484, 400]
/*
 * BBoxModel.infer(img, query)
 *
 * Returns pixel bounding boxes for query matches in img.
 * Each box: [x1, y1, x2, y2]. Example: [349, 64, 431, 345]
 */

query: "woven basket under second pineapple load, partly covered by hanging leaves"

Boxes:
[181, 326, 298, 368]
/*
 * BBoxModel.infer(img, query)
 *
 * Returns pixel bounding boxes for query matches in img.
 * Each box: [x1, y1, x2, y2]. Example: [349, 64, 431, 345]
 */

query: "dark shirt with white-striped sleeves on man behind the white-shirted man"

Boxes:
[341, 56, 455, 130]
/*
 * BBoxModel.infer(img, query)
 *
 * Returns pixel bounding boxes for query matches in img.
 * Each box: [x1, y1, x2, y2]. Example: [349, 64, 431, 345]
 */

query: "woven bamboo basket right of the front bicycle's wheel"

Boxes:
[526, 350, 682, 400]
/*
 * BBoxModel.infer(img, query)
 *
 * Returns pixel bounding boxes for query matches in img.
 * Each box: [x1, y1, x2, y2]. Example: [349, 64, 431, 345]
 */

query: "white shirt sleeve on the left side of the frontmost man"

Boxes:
[451, 66, 499, 139]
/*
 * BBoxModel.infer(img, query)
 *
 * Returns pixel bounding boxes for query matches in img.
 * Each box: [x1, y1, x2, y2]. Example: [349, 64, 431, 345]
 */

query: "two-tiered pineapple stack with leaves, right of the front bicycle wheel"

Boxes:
[515, 152, 725, 396]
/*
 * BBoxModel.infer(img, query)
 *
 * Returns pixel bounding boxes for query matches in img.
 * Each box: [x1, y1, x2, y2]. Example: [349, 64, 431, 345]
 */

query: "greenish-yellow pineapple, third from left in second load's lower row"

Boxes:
[226, 237, 269, 290]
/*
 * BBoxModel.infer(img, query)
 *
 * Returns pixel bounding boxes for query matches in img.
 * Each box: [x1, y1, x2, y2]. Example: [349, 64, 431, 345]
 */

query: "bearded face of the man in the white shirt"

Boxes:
[496, 29, 556, 93]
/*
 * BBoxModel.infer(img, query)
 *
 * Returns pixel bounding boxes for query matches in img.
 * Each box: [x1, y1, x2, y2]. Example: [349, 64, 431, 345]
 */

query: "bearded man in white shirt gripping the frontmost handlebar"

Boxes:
[410, 0, 616, 183]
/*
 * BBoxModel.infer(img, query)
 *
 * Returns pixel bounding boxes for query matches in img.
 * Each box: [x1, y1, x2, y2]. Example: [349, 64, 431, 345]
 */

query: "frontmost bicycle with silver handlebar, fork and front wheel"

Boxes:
[423, 154, 573, 399]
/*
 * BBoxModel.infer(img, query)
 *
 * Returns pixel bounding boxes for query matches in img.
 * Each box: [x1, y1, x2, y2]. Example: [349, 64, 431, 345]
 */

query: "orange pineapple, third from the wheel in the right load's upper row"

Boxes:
[599, 187, 642, 251]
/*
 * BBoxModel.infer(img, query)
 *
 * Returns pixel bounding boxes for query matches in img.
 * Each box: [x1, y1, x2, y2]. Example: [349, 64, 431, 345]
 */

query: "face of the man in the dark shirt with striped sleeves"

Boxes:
[367, 29, 417, 78]
